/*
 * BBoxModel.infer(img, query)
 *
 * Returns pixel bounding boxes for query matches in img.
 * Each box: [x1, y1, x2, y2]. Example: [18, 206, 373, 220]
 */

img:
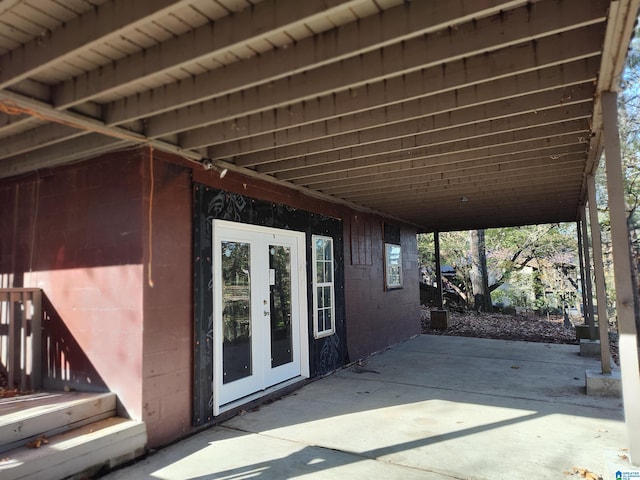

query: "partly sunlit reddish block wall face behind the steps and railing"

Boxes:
[0, 153, 143, 418]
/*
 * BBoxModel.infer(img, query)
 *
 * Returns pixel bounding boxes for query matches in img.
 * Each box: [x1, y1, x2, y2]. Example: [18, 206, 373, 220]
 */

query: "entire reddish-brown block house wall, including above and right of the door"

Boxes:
[0, 149, 420, 447]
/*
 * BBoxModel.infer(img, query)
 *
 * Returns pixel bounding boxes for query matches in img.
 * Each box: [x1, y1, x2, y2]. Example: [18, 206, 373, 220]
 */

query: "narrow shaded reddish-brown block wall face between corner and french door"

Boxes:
[142, 151, 193, 447]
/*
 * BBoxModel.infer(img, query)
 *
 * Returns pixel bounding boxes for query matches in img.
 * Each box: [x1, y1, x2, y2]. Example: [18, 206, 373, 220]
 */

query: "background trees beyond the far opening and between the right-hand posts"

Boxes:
[418, 27, 640, 318]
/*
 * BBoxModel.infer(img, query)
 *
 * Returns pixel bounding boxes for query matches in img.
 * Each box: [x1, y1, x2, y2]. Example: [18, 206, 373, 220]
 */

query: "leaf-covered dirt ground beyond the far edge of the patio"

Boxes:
[420, 305, 618, 364]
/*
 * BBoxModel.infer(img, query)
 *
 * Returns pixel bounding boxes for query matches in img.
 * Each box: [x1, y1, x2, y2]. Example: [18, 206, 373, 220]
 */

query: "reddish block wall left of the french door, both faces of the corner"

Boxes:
[0, 149, 193, 447]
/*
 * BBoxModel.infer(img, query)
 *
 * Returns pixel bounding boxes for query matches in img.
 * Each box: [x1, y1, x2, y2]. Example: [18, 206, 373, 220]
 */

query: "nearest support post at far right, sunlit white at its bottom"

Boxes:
[602, 92, 640, 466]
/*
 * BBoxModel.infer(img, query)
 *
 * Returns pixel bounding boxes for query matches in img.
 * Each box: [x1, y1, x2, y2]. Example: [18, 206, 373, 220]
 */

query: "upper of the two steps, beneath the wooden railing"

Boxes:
[0, 392, 116, 455]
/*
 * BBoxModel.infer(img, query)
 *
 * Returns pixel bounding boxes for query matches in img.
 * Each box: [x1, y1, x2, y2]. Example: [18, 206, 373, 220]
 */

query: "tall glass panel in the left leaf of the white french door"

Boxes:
[221, 242, 252, 383]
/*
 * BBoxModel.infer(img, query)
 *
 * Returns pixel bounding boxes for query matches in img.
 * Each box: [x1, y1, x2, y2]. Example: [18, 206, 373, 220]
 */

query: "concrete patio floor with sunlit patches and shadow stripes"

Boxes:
[103, 335, 628, 480]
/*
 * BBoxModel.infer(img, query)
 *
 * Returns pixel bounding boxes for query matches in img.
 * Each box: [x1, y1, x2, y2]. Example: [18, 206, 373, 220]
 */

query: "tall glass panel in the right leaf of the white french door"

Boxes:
[269, 245, 293, 368]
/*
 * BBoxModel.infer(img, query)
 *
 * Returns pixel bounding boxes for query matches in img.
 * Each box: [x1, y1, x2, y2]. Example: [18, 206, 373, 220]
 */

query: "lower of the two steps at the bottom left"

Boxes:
[0, 417, 147, 480]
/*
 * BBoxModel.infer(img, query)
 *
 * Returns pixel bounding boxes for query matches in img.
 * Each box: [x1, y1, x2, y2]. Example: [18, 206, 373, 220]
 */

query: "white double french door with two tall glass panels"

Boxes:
[213, 220, 309, 415]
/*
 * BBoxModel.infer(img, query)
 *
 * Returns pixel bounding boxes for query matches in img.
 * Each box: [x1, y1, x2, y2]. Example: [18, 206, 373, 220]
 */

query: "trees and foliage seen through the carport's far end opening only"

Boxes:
[418, 224, 579, 311]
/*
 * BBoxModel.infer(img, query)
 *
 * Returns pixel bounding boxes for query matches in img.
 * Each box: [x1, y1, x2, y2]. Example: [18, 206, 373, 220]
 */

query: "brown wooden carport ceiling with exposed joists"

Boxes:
[0, 0, 639, 231]
